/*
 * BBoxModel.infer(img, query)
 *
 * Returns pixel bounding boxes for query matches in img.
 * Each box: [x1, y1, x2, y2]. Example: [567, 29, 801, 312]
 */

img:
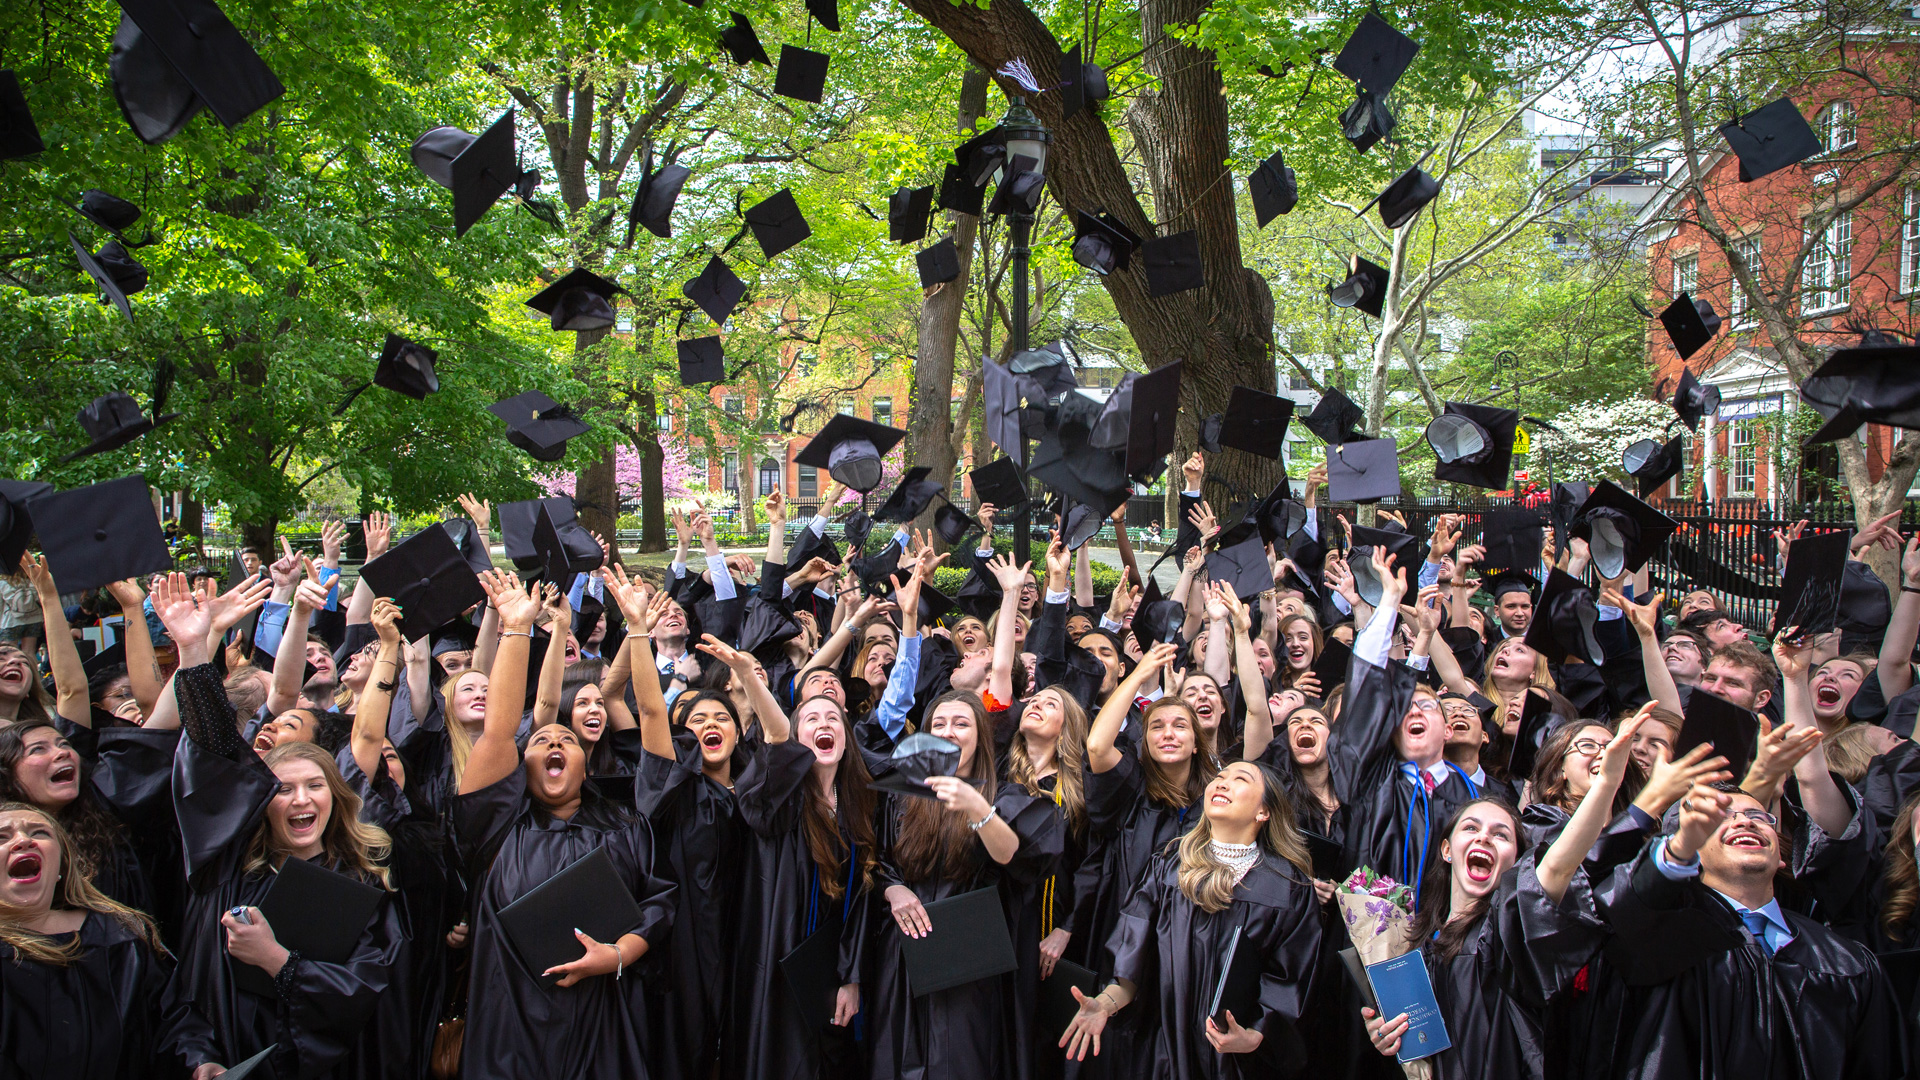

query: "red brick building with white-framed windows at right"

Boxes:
[1642, 50, 1920, 502]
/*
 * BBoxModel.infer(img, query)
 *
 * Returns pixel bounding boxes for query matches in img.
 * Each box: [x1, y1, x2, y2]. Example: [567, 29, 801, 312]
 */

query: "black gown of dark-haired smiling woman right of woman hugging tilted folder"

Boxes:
[634, 732, 745, 1080]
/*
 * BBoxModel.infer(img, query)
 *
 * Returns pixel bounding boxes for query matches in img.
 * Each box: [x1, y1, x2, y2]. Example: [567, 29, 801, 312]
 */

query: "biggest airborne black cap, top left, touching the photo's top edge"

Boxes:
[108, 0, 286, 144]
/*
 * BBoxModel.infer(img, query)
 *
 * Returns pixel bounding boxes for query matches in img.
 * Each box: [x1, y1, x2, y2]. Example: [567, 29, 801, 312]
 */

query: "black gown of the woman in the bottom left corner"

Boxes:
[0, 913, 215, 1080]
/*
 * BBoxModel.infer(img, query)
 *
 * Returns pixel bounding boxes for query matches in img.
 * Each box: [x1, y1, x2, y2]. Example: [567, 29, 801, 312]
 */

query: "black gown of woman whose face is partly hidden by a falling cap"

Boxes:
[862, 786, 1066, 1080]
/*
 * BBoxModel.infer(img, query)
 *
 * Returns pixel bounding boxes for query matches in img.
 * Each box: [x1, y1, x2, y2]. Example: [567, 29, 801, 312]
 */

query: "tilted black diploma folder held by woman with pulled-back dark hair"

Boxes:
[497, 847, 641, 986]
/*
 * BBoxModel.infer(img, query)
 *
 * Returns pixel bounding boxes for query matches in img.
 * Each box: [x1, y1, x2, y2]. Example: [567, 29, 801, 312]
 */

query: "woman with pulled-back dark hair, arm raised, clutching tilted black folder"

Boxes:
[451, 571, 674, 1080]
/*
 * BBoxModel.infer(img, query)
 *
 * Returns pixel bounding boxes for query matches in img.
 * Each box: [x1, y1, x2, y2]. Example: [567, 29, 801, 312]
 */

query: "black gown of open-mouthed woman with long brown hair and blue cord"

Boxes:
[720, 740, 872, 1080]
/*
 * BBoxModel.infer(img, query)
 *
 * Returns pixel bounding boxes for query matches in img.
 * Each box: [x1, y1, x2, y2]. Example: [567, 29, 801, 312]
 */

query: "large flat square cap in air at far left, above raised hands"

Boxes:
[25, 477, 173, 594]
